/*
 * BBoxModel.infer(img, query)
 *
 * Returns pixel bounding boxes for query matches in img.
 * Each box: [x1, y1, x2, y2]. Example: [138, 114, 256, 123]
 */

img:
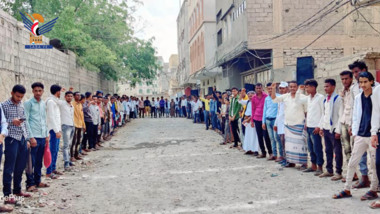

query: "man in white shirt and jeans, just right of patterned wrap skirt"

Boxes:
[297, 79, 325, 176]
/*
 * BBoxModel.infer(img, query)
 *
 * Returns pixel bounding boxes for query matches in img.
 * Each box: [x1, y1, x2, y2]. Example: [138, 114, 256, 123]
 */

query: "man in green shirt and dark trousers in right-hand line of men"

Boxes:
[229, 88, 241, 148]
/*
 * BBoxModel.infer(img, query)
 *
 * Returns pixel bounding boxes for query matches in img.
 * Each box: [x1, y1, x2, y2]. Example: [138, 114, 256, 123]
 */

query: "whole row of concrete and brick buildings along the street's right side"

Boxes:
[181, 0, 380, 93]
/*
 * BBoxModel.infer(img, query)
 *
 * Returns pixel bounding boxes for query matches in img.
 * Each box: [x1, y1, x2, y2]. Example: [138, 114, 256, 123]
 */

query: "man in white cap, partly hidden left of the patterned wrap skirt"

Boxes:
[272, 82, 289, 165]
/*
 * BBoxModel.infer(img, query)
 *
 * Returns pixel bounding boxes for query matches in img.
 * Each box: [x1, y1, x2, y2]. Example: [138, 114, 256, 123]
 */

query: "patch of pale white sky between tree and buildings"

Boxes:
[135, 0, 182, 62]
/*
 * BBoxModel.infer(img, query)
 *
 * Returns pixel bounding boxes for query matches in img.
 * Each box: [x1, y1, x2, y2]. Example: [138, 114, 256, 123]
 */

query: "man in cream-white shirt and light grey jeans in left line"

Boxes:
[58, 91, 74, 171]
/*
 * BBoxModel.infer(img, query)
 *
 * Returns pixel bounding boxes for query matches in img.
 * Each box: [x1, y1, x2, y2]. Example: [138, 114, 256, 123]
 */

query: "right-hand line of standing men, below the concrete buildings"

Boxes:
[188, 61, 380, 208]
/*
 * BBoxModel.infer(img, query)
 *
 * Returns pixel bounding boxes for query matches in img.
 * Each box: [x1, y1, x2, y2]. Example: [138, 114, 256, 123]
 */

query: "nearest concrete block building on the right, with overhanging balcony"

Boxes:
[215, 0, 380, 87]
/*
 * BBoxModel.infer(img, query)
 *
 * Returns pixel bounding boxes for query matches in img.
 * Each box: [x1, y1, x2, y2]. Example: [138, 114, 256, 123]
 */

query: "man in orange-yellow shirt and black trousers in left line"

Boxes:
[70, 92, 86, 162]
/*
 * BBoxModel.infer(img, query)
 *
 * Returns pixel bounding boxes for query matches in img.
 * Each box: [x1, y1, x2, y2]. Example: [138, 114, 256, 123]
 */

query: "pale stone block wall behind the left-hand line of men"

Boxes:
[0, 10, 116, 101]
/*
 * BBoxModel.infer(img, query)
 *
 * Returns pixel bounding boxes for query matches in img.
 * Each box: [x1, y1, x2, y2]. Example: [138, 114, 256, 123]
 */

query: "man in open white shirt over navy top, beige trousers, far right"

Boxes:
[333, 72, 379, 201]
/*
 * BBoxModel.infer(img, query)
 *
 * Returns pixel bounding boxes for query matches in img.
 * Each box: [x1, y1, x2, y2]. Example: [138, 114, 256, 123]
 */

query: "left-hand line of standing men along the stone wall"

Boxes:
[0, 82, 138, 212]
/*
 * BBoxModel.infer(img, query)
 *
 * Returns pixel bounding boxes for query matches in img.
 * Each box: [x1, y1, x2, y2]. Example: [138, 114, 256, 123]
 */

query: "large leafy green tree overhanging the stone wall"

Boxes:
[0, 0, 159, 85]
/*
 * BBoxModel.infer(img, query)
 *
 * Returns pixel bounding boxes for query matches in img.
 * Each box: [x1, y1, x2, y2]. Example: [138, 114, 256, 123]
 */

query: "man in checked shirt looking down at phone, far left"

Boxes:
[1, 85, 31, 203]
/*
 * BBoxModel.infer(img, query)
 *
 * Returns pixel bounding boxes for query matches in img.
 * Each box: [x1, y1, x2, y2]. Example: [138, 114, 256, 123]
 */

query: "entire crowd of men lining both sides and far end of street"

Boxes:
[0, 61, 380, 212]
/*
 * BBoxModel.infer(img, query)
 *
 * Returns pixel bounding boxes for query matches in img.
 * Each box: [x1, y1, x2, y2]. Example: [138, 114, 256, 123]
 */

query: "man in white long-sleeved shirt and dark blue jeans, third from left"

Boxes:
[46, 85, 63, 179]
